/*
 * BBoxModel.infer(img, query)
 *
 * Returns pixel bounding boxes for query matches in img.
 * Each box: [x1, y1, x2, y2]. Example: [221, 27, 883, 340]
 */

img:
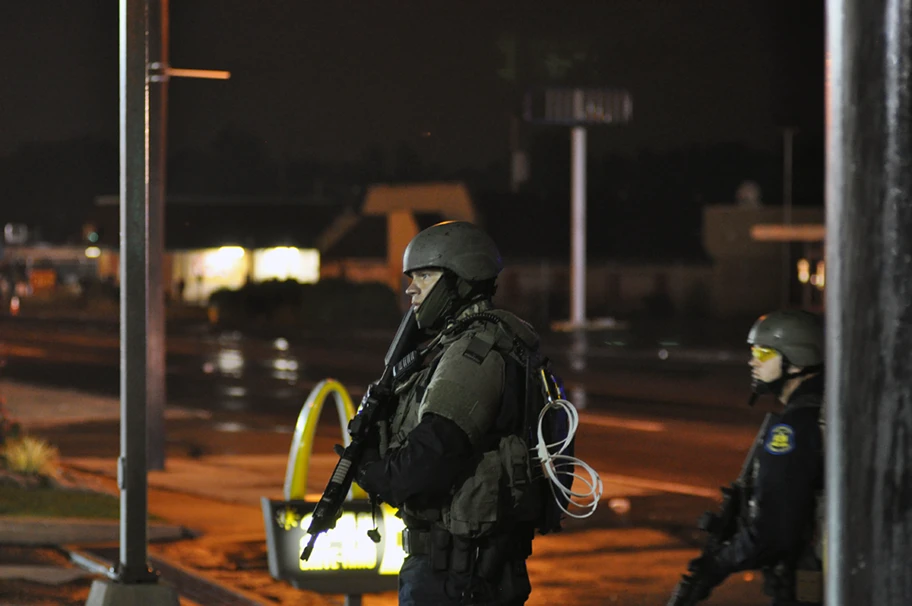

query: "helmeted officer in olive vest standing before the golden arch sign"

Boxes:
[357, 222, 538, 606]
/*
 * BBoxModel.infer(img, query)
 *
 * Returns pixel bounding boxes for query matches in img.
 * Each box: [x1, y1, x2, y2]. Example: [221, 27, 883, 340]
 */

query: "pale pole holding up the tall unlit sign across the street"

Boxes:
[570, 90, 586, 328]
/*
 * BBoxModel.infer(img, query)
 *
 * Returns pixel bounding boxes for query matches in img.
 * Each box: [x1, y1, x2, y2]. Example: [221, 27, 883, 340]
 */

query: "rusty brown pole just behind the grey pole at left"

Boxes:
[146, 0, 169, 470]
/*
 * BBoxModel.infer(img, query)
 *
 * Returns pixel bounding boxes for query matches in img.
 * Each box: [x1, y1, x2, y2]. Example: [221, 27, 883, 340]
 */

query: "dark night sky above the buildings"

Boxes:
[0, 0, 824, 256]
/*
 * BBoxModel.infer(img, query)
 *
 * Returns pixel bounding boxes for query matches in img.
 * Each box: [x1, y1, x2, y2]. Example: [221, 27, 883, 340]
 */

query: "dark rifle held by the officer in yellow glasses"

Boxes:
[668, 414, 773, 606]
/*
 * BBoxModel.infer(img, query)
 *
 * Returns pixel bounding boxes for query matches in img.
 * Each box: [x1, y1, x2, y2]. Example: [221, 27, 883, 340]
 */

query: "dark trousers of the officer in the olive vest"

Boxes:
[399, 554, 531, 606]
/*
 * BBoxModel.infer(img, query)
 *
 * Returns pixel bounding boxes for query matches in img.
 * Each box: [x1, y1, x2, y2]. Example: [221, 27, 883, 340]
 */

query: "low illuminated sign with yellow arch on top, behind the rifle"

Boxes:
[261, 379, 405, 595]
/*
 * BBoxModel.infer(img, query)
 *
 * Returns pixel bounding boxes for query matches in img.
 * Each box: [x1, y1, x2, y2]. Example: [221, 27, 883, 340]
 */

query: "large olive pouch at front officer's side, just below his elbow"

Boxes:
[443, 450, 503, 539]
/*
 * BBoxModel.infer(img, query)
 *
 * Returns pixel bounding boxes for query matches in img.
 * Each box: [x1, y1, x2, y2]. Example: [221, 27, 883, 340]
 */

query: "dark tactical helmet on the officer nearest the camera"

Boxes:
[402, 221, 503, 282]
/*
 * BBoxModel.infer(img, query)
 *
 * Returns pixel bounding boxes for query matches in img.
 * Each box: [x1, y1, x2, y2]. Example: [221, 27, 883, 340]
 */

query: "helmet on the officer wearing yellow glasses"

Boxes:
[747, 310, 824, 367]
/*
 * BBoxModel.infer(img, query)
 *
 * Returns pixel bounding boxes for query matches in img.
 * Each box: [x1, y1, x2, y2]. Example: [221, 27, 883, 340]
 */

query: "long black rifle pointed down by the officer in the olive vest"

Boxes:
[301, 307, 418, 560]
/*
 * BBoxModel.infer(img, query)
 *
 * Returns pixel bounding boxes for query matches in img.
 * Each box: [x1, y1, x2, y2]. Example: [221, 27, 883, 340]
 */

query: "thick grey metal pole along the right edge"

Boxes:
[825, 0, 912, 606]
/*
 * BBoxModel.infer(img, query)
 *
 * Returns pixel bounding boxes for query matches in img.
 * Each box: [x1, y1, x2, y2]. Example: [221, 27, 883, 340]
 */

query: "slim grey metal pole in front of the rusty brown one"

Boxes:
[118, 0, 155, 584]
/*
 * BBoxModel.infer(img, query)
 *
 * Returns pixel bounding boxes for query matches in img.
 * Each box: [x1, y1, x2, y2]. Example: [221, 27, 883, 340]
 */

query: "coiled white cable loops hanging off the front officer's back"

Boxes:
[532, 398, 602, 519]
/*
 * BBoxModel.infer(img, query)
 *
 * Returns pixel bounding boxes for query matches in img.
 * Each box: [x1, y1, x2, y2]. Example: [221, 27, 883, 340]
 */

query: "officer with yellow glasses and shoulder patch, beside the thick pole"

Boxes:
[691, 311, 824, 606]
